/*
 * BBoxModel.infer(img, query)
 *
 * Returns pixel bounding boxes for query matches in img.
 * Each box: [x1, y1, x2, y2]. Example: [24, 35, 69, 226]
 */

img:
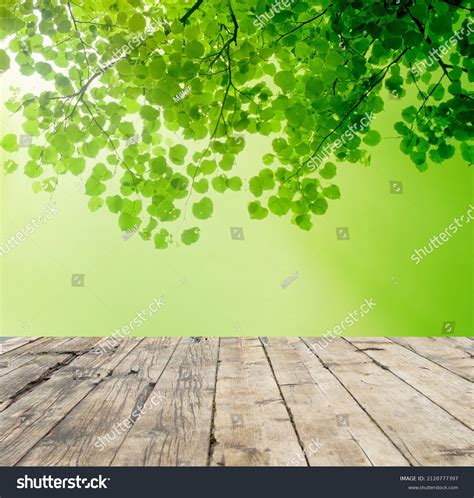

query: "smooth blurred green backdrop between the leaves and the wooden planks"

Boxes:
[0, 66, 474, 336]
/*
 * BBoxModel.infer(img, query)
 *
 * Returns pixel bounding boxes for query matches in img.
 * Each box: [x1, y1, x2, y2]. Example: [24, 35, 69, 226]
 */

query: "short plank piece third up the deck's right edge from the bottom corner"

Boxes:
[390, 337, 474, 382]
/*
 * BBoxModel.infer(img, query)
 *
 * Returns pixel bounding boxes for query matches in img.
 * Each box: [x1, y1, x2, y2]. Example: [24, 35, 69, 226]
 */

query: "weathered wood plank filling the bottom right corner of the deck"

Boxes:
[306, 339, 474, 466]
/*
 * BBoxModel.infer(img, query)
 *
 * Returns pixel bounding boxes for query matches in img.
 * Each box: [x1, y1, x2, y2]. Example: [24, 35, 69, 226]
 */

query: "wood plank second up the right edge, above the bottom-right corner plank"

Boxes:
[346, 337, 474, 429]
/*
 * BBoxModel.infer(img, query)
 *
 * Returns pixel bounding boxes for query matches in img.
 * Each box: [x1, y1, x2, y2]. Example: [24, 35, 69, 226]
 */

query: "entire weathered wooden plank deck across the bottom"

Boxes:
[0, 337, 474, 466]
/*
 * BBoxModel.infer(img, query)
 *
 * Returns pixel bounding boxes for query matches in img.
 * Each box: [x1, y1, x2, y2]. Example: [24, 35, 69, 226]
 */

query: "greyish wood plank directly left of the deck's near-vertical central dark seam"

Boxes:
[112, 337, 218, 466]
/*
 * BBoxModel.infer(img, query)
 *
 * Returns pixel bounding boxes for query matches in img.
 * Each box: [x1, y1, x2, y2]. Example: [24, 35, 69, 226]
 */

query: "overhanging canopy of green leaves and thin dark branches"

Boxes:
[0, 0, 474, 249]
